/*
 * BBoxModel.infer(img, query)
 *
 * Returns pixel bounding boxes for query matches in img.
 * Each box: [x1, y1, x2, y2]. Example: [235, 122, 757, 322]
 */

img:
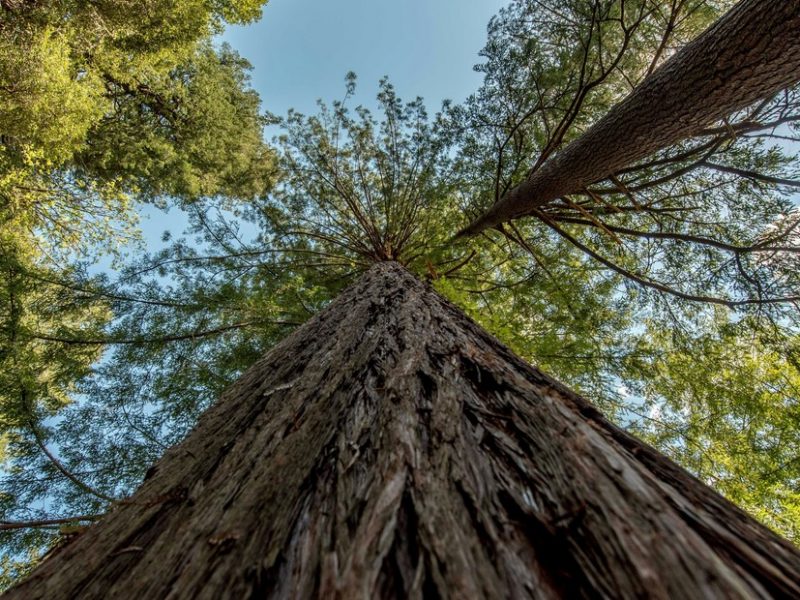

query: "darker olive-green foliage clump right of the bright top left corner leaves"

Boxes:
[77, 44, 271, 201]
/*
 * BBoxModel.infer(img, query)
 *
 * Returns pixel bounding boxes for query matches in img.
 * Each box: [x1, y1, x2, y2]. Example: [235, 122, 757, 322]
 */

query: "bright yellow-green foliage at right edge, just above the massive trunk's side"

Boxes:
[630, 322, 800, 542]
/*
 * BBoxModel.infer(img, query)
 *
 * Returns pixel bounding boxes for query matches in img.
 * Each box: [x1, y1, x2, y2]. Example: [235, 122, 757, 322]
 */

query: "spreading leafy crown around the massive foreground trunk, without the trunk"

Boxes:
[2, 58, 800, 584]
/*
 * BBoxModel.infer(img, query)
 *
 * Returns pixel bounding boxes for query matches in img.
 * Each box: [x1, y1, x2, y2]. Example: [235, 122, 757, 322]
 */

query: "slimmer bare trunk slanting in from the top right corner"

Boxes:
[460, 0, 800, 235]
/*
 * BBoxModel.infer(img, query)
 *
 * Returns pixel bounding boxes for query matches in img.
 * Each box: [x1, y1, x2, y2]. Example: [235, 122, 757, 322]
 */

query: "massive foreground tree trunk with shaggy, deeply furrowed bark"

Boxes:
[8, 263, 800, 600]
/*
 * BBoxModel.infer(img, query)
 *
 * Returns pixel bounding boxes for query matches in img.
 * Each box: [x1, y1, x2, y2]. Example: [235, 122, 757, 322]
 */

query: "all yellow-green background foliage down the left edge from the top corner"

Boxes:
[0, 0, 273, 580]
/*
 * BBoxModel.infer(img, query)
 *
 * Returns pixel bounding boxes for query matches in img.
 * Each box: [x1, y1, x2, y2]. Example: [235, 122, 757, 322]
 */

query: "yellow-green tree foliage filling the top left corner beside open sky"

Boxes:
[0, 0, 272, 255]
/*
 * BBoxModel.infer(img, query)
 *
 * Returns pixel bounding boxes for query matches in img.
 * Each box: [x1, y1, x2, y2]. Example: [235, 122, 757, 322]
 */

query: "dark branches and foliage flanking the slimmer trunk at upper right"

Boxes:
[450, 2, 797, 310]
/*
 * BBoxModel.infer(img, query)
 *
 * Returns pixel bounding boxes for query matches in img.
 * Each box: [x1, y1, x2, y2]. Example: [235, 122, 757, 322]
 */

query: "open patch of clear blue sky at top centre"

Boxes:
[223, 0, 508, 115]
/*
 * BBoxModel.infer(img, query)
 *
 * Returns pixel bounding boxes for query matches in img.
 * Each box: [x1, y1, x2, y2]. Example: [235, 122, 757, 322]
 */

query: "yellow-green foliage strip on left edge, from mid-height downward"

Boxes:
[0, 234, 111, 579]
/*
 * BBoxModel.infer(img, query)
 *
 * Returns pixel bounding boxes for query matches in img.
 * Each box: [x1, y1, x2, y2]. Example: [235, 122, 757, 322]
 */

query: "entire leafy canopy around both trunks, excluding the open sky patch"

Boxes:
[0, 0, 800, 585]
